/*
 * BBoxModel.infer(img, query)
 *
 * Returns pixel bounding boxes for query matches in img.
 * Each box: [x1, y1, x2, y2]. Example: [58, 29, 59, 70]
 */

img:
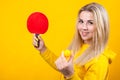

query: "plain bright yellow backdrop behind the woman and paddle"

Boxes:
[0, 0, 120, 80]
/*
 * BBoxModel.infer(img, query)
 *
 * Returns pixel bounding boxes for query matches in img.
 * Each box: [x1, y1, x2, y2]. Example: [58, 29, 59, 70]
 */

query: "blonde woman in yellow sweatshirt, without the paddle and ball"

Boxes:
[33, 3, 115, 80]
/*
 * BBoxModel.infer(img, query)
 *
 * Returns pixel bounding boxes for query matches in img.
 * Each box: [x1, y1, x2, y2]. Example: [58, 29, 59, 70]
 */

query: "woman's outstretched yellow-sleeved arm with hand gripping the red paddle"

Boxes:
[33, 35, 57, 70]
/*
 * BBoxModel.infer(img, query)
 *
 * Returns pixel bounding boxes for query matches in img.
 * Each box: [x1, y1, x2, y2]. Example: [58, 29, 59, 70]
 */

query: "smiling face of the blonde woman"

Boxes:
[77, 11, 96, 43]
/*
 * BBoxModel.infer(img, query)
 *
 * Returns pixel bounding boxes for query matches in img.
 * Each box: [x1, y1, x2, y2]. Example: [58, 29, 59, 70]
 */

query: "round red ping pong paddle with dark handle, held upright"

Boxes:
[27, 12, 48, 47]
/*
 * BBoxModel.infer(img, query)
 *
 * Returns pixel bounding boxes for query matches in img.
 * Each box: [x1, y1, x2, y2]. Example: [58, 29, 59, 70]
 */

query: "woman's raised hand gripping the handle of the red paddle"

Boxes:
[33, 34, 46, 53]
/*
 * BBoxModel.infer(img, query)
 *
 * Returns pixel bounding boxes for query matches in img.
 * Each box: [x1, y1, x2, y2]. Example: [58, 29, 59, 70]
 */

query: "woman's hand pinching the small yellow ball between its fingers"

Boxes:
[55, 52, 74, 78]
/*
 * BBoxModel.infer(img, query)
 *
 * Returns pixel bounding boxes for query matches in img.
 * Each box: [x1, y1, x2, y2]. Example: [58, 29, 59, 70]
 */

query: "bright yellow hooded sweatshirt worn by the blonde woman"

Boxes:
[41, 45, 116, 80]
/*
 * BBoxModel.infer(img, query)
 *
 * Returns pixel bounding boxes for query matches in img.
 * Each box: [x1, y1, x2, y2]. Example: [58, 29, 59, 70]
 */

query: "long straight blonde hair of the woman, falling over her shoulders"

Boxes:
[69, 3, 109, 65]
